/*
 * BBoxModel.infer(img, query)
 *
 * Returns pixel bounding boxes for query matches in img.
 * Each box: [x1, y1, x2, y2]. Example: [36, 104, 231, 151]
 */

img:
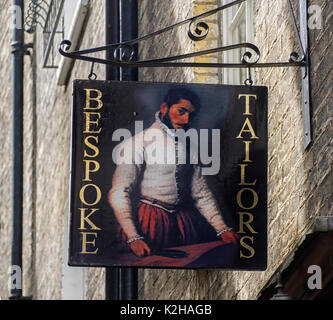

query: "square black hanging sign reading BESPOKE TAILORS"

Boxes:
[69, 80, 267, 270]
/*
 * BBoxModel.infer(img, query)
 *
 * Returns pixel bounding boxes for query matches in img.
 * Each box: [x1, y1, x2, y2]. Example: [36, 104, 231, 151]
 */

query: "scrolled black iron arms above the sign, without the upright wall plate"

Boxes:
[59, 0, 307, 68]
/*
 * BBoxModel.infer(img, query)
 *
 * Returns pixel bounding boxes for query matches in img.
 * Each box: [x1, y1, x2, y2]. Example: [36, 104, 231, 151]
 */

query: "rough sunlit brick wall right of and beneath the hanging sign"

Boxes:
[136, 1, 333, 299]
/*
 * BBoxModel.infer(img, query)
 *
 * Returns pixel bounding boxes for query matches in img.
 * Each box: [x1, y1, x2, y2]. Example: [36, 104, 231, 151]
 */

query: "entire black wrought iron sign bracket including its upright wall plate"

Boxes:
[59, 0, 311, 148]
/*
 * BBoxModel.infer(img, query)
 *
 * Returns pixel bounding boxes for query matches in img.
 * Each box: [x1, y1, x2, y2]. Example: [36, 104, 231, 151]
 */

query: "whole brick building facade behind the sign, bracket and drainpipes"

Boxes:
[0, 0, 333, 300]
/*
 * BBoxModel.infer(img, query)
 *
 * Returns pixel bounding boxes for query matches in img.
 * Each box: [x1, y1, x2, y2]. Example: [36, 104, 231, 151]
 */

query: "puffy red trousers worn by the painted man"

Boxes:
[121, 202, 197, 249]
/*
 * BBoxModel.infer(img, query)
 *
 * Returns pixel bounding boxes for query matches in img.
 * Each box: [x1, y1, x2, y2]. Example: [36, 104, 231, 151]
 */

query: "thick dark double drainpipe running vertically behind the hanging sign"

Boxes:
[105, 0, 138, 300]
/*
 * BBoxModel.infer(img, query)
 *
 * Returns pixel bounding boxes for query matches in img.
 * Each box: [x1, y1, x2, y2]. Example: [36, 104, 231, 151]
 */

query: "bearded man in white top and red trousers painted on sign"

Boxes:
[108, 87, 238, 257]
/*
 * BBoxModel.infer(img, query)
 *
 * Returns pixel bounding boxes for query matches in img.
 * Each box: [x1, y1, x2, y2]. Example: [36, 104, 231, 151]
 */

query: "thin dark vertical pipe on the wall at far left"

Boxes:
[10, 0, 25, 300]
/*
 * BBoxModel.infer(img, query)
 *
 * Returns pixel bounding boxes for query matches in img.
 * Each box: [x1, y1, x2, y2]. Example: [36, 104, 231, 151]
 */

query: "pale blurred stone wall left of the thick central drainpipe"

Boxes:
[0, 1, 105, 299]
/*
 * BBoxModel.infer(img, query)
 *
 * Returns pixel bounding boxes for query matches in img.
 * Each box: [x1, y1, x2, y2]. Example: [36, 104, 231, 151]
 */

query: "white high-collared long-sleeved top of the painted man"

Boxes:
[109, 113, 228, 239]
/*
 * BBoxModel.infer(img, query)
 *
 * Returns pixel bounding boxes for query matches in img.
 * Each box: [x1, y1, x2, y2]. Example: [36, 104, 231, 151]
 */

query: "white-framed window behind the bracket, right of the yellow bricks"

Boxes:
[222, 0, 254, 85]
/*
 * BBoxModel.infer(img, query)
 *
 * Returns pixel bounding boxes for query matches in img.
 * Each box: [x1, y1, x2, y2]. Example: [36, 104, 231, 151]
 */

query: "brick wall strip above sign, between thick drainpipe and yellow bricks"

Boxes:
[139, 0, 193, 82]
